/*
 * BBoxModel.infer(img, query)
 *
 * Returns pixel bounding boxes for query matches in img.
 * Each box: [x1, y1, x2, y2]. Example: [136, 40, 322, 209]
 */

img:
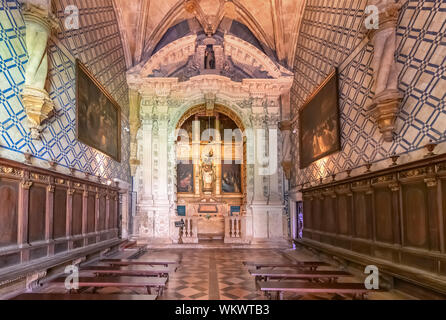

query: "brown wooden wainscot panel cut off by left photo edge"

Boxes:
[0, 180, 18, 247]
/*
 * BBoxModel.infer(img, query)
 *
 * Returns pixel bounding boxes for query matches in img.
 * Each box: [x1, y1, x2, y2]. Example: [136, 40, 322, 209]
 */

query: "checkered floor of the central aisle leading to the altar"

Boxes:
[150, 249, 284, 300]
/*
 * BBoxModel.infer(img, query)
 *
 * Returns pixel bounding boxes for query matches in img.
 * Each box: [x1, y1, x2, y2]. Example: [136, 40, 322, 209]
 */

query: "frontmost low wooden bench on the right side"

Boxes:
[259, 281, 379, 300]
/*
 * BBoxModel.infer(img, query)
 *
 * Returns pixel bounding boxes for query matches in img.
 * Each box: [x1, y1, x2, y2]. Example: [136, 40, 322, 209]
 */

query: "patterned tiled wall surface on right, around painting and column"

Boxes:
[291, 0, 446, 186]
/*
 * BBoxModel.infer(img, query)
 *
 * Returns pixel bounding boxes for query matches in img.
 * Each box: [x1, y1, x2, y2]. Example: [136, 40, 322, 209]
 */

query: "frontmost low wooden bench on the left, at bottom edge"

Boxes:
[11, 293, 158, 300]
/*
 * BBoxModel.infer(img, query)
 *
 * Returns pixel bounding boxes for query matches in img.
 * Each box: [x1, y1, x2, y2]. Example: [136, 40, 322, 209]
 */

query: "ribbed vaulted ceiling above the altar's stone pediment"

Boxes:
[114, 0, 305, 68]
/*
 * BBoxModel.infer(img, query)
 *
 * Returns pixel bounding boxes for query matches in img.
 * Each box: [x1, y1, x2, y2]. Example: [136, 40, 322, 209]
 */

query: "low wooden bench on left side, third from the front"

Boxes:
[81, 265, 175, 279]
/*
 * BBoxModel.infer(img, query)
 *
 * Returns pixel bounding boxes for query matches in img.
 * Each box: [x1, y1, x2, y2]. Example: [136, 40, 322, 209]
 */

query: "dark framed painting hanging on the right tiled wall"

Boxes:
[299, 70, 341, 169]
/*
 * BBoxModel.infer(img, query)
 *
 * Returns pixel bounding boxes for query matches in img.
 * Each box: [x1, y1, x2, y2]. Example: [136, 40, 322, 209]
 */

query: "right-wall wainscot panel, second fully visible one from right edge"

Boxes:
[375, 188, 393, 243]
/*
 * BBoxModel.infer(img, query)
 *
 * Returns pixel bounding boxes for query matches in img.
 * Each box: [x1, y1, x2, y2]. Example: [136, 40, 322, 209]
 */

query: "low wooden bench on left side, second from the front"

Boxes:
[54, 277, 167, 296]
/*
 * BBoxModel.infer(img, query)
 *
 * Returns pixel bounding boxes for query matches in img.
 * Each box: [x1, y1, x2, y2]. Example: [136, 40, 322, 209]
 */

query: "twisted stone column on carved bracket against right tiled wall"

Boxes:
[368, 0, 402, 142]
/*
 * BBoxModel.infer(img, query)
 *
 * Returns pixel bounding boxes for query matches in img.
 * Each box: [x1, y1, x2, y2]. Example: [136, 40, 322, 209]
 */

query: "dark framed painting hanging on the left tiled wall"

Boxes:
[76, 60, 121, 162]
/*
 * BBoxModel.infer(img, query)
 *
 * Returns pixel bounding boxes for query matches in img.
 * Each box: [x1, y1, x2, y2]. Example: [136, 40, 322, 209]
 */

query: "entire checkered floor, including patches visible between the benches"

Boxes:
[40, 249, 411, 300]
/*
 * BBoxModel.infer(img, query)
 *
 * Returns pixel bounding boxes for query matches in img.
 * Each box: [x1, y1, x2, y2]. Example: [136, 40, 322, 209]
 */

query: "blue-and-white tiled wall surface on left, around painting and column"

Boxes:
[0, 0, 130, 181]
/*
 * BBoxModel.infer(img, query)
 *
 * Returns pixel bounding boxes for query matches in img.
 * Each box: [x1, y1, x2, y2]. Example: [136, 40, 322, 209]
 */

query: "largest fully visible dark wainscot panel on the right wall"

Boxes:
[403, 182, 428, 248]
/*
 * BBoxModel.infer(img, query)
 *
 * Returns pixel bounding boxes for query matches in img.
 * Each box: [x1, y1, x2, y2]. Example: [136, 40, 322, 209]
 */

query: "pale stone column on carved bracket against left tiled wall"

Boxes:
[21, 0, 59, 139]
